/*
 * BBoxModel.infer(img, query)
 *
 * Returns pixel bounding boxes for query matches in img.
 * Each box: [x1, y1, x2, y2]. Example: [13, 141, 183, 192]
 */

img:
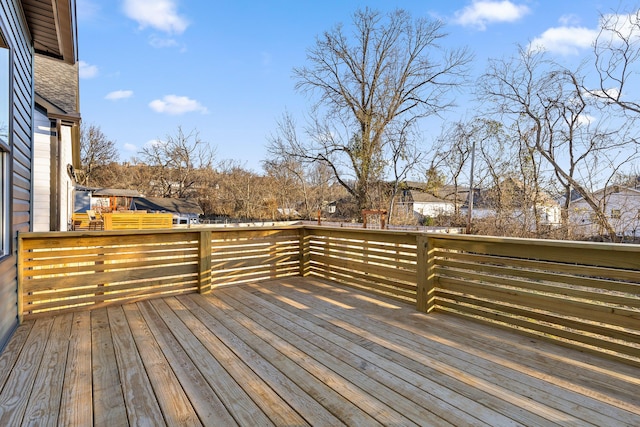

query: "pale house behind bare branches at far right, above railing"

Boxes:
[569, 185, 640, 237]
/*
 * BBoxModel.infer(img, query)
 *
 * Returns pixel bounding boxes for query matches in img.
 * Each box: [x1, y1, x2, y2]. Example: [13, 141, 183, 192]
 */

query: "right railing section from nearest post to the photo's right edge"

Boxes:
[423, 235, 640, 365]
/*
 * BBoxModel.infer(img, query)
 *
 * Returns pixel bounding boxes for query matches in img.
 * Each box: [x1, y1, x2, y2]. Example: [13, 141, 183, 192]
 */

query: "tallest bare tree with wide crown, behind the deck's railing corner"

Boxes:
[276, 9, 471, 217]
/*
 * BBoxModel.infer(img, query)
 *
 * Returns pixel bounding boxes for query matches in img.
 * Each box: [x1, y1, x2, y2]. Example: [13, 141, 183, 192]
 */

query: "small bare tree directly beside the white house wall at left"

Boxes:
[78, 124, 118, 186]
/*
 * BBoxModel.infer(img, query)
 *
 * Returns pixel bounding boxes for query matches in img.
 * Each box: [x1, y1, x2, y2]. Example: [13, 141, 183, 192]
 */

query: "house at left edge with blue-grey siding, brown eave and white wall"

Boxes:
[0, 0, 79, 348]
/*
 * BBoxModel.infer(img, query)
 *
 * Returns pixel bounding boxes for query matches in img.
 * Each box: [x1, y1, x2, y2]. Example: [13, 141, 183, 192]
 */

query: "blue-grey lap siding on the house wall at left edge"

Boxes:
[0, 0, 34, 348]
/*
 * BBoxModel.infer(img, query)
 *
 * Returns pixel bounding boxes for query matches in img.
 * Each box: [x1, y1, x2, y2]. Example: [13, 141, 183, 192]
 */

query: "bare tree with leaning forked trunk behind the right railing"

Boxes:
[480, 48, 629, 240]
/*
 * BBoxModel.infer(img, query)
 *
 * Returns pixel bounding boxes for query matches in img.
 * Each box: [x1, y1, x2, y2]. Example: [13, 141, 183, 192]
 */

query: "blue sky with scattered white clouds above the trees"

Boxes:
[77, 0, 618, 172]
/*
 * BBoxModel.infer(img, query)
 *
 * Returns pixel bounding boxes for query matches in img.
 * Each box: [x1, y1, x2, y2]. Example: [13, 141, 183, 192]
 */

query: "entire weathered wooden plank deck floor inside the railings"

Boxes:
[0, 277, 640, 426]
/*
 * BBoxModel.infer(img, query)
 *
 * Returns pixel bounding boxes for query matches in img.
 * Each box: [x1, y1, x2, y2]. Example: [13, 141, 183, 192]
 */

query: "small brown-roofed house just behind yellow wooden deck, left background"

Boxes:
[74, 186, 144, 212]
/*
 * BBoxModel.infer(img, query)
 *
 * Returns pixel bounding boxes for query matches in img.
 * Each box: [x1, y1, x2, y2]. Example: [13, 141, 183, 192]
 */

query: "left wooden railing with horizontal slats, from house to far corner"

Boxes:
[18, 228, 300, 318]
